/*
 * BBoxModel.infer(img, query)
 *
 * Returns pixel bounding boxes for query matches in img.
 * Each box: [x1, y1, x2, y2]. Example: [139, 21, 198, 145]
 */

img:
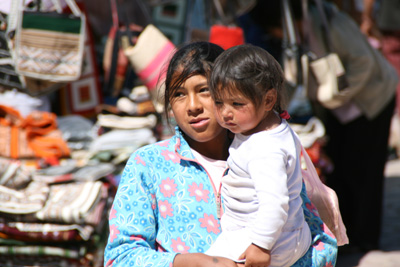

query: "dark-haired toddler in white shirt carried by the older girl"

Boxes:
[207, 45, 311, 267]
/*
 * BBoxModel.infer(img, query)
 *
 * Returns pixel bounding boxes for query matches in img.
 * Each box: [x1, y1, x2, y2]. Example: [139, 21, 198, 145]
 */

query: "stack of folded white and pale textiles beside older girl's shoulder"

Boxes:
[87, 86, 159, 171]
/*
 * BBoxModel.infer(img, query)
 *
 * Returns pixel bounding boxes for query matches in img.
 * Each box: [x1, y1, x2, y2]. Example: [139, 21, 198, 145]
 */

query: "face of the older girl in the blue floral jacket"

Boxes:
[171, 75, 226, 153]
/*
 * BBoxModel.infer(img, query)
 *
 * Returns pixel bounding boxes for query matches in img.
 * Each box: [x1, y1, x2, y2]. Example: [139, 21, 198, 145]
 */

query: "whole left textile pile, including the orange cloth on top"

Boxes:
[0, 105, 116, 266]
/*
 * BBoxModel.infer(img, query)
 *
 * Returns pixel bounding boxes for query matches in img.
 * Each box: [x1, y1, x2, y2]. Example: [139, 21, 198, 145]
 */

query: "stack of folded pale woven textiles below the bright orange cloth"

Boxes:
[0, 159, 115, 266]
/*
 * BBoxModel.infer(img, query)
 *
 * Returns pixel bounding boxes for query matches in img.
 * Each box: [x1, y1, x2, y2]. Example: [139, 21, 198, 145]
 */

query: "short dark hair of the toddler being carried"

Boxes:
[208, 44, 286, 113]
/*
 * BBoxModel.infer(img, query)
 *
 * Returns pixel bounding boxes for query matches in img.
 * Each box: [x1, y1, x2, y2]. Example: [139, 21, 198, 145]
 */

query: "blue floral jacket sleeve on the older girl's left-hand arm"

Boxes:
[104, 153, 176, 267]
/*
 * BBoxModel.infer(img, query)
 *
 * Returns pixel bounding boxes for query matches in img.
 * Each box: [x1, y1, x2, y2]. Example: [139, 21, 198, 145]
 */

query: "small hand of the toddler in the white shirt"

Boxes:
[238, 244, 271, 267]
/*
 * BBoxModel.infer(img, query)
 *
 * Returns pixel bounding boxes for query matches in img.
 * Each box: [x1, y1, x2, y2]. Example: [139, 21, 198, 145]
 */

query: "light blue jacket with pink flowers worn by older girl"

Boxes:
[104, 129, 337, 267]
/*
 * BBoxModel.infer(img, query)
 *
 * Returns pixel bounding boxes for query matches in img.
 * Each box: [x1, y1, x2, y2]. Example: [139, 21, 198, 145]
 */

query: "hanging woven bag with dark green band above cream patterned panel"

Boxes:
[15, 0, 85, 82]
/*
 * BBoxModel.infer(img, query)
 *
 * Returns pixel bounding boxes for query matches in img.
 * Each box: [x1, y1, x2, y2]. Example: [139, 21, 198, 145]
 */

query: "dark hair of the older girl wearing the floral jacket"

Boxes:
[164, 42, 224, 119]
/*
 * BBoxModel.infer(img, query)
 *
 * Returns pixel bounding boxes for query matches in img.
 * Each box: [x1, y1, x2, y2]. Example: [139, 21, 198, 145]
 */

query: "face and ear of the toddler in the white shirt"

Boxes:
[215, 90, 276, 135]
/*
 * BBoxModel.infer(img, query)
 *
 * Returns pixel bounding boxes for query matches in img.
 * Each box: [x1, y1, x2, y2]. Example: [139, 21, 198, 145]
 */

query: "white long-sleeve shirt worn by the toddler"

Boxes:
[209, 120, 311, 266]
